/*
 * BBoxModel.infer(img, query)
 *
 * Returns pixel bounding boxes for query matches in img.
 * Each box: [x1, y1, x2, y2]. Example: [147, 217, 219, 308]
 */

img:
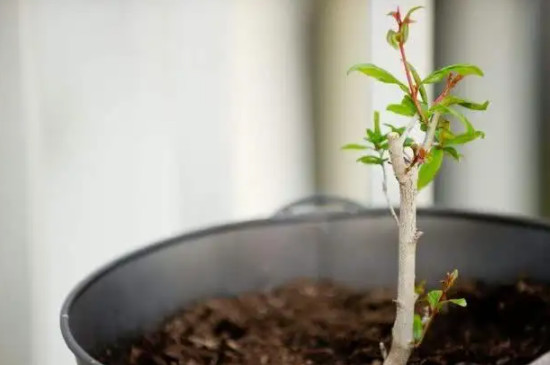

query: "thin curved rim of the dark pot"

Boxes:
[60, 207, 550, 365]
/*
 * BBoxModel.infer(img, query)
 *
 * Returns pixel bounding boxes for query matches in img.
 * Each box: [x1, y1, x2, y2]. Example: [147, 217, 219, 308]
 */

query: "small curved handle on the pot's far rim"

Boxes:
[273, 194, 366, 219]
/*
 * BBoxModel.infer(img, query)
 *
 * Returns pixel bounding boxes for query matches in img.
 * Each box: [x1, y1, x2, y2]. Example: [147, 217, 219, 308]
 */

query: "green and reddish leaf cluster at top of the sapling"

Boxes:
[344, 7, 489, 189]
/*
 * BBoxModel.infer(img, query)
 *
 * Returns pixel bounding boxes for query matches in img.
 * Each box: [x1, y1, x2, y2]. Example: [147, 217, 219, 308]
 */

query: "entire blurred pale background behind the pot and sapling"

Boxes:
[0, 0, 550, 365]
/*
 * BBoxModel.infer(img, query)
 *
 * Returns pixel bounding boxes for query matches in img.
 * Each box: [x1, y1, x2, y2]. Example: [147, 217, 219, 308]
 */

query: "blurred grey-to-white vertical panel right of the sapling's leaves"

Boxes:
[435, 0, 548, 215]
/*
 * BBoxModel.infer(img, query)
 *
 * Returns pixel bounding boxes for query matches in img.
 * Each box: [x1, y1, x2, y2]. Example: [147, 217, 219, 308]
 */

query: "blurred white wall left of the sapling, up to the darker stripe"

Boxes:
[4, 0, 312, 365]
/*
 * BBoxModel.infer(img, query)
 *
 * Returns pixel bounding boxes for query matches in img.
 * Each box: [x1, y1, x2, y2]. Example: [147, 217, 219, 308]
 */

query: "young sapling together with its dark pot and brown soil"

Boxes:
[61, 8, 550, 365]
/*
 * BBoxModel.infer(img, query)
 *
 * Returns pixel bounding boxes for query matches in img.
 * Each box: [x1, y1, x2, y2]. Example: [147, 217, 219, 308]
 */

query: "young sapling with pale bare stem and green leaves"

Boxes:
[343, 6, 489, 365]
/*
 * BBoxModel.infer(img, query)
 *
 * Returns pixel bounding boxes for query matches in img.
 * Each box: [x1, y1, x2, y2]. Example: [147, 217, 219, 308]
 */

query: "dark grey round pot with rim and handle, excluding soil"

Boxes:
[61, 197, 550, 365]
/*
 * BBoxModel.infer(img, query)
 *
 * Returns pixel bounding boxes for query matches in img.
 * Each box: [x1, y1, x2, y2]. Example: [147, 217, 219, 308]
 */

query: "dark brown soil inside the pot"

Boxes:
[99, 281, 550, 365]
